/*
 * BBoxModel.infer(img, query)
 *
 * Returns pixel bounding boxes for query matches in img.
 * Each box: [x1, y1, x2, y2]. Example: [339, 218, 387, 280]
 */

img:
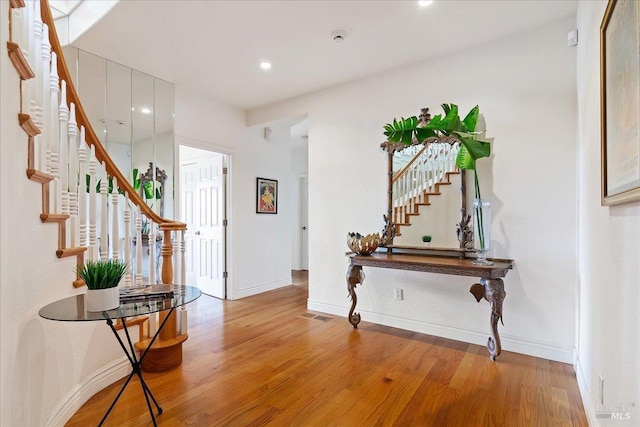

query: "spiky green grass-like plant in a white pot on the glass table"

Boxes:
[77, 259, 128, 311]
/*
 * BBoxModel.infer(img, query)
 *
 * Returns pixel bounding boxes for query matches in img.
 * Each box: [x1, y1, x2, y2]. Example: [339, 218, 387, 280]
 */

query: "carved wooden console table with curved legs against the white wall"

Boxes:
[347, 252, 513, 360]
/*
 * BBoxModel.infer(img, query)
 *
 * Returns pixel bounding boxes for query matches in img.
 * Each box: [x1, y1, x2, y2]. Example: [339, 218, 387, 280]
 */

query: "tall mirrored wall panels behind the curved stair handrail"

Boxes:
[63, 46, 175, 222]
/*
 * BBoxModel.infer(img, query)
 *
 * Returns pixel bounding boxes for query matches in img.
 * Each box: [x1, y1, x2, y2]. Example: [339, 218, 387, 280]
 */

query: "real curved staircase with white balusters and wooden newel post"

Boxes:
[7, 0, 188, 371]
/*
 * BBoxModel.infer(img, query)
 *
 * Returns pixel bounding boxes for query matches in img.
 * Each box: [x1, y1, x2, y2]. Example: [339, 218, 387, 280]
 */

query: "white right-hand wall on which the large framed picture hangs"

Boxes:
[576, 1, 640, 426]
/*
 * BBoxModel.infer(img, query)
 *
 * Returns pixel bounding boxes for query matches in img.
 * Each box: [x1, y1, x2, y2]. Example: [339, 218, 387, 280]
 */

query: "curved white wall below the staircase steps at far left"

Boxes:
[0, 1, 131, 426]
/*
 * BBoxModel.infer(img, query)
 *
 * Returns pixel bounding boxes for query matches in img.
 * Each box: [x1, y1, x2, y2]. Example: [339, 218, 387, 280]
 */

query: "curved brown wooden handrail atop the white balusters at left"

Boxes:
[40, 0, 187, 230]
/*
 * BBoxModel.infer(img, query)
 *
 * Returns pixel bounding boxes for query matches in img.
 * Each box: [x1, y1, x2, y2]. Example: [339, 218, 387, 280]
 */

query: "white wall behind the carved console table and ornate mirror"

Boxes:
[248, 19, 577, 362]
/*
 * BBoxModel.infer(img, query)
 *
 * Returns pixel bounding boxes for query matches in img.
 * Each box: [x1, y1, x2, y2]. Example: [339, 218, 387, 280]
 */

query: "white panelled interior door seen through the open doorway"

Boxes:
[181, 154, 225, 298]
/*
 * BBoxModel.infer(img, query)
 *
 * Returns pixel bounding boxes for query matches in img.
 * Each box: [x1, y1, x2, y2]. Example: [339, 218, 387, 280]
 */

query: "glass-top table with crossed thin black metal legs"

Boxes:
[39, 286, 202, 426]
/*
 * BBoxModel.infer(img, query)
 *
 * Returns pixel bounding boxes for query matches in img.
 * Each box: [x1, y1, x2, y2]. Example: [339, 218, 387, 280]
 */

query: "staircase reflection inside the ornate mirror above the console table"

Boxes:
[392, 141, 460, 236]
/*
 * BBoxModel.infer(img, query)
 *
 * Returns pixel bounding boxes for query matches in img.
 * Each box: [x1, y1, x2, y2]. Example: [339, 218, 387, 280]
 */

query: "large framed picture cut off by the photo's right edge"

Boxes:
[600, 0, 640, 206]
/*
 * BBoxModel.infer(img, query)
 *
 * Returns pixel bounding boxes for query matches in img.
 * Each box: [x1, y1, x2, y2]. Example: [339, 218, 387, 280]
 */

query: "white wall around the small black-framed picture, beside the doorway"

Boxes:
[175, 86, 293, 299]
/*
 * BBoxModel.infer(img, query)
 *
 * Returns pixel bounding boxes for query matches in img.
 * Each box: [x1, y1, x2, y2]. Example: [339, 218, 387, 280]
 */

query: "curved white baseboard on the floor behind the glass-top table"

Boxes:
[45, 356, 131, 427]
